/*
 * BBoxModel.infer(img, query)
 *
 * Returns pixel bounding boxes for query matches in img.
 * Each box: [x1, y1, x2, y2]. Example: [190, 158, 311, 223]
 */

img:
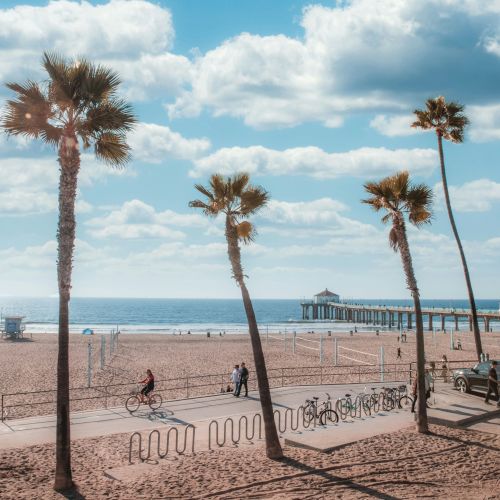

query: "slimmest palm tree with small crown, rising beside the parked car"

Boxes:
[412, 96, 483, 359]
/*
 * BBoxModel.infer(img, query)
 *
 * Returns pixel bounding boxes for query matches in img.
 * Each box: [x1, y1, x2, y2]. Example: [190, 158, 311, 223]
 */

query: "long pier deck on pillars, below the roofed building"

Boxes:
[300, 300, 500, 332]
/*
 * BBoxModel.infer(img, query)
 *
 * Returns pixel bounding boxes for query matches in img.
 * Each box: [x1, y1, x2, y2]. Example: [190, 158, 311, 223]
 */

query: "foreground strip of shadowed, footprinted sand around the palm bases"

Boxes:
[0, 426, 500, 500]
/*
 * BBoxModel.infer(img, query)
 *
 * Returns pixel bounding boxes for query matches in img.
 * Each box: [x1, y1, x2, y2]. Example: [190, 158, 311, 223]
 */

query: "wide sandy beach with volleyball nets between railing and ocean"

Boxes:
[0, 332, 500, 418]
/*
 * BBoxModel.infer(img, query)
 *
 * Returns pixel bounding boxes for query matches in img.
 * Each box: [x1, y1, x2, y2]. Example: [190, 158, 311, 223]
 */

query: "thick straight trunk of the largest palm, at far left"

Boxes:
[54, 130, 80, 491]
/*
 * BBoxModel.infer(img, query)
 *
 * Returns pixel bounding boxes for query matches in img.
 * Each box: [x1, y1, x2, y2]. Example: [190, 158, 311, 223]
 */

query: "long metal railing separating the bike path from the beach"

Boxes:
[0, 363, 414, 421]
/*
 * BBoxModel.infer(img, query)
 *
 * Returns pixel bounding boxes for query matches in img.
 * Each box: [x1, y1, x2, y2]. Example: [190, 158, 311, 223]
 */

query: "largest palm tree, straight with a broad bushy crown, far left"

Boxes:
[1, 53, 136, 490]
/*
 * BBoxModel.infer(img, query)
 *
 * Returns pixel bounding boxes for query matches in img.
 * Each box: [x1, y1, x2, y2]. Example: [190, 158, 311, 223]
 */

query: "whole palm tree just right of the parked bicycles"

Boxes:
[362, 171, 432, 432]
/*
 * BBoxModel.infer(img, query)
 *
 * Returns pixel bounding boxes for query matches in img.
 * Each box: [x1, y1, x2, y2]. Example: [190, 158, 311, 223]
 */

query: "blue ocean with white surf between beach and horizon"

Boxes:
[0, 297, 499, 334]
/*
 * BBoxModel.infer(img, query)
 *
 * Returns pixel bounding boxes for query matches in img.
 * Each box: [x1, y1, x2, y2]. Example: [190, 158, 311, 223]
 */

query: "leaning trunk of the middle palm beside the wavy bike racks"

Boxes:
[226, 215, 283, 459]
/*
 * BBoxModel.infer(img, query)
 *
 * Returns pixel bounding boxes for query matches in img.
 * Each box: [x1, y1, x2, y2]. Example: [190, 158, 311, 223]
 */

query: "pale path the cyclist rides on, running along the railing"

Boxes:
[0, 383, 392, 449]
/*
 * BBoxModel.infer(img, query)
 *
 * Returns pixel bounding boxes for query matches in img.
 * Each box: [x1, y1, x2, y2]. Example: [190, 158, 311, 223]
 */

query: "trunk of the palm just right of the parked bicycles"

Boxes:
[394, 213, 429, 433]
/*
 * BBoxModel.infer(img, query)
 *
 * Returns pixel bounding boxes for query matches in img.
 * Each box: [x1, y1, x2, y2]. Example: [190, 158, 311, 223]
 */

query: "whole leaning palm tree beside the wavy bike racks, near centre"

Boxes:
[189, 174, 283, 459]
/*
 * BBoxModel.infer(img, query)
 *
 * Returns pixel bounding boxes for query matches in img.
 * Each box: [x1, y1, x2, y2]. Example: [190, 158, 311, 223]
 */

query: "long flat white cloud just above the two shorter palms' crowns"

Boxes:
[190, 146, 437, 179]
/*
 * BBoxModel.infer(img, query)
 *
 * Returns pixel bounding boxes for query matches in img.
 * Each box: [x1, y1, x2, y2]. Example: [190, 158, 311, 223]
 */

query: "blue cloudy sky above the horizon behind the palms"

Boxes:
[0, 0, 500, 299]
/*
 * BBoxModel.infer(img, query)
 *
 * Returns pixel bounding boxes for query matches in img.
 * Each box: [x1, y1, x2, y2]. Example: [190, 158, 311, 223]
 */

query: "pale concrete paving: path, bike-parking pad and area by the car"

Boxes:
[0, 383, 500, 450]
